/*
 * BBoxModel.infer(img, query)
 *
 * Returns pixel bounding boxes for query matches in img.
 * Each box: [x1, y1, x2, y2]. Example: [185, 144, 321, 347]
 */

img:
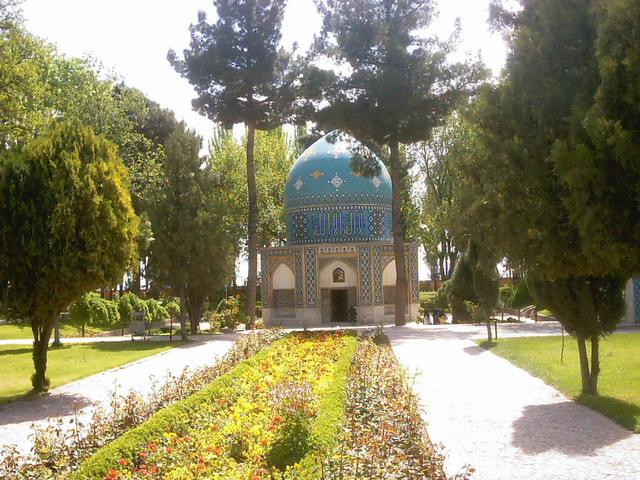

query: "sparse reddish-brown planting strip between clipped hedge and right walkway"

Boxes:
[319, 336, 473, 480]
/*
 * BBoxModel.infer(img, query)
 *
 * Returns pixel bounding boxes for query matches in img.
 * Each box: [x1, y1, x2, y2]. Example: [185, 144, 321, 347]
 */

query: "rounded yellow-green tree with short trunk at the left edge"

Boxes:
[0, 122, 138, 392]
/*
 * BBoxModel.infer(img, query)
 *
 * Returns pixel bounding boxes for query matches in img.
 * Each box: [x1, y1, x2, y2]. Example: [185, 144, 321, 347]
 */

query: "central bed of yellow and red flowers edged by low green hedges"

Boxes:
[72, 332, 356, 480]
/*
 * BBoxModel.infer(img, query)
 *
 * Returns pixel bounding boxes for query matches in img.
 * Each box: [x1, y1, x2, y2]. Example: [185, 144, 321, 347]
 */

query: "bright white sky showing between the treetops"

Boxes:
[23, 0, 506, 279]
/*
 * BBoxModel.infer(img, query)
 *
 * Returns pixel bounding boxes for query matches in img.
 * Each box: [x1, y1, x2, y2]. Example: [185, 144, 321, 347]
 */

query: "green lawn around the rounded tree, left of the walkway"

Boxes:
[0, 341, 181, 404]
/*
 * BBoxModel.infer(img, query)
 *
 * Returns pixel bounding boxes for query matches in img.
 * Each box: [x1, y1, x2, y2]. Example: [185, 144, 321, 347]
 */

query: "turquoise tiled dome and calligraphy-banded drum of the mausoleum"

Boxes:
[284, 131, 392, 245]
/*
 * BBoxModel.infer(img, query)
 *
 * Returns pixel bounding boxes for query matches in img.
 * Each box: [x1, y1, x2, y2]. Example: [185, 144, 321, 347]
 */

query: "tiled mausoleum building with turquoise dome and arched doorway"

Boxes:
[260, 131, 419, 326]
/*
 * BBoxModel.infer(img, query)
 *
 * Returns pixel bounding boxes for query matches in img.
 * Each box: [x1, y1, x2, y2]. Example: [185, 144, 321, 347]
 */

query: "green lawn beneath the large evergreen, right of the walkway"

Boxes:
[478, 333, 640, 433]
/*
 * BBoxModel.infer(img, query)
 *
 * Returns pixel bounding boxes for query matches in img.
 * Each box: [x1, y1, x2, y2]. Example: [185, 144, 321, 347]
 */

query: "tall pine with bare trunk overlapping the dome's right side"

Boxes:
[308, 0, 484, 325]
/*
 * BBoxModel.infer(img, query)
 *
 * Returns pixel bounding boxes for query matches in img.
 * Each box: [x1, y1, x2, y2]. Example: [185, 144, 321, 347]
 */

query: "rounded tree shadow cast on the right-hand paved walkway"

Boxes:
[512, 401, 632, 456]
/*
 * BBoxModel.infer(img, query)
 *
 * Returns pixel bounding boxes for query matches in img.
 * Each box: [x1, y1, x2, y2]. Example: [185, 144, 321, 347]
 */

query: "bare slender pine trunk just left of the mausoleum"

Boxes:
[247, 124, 258, 328]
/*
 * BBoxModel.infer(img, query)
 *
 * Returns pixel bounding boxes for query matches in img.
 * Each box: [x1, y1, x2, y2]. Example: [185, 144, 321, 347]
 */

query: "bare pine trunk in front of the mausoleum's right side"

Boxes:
[389, 141, 407, 326]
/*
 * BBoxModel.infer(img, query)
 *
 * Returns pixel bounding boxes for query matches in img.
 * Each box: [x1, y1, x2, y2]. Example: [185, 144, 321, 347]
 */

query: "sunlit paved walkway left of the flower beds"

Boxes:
[0, 334, 235, 453]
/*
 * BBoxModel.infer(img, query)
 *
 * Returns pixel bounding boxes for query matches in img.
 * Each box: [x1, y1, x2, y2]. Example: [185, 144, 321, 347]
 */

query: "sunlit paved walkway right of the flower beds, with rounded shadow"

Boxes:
[385, 324, 640, 480]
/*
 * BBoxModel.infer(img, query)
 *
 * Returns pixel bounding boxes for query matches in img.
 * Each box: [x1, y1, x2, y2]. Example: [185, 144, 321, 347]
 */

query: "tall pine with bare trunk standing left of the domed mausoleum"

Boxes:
[168, 0, 296, 327]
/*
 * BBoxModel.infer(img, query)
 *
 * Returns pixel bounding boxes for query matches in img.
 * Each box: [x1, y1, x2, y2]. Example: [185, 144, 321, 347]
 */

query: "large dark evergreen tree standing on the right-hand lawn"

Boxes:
[450, 0, 640, 394]
